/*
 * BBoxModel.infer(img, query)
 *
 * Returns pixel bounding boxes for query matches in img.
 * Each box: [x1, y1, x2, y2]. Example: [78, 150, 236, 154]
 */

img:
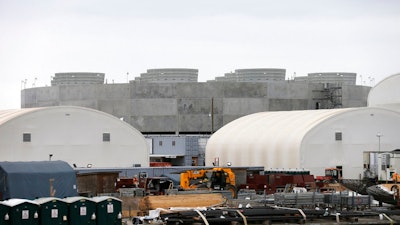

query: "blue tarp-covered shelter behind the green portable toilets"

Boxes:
[0, 161, 78, 200]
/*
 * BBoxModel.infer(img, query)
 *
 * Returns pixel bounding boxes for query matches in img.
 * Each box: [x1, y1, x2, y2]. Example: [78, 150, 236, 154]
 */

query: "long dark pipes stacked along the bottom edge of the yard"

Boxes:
[134, 207, 398, 225]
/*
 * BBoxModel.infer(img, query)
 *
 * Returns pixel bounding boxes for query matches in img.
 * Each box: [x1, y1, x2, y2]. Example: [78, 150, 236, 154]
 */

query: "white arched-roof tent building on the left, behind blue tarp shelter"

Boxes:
[0, 106, 149, 167]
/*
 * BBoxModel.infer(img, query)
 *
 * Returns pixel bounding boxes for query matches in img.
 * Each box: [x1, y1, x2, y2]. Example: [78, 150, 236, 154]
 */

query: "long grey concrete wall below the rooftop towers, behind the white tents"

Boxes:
[21, 81, 370, 134]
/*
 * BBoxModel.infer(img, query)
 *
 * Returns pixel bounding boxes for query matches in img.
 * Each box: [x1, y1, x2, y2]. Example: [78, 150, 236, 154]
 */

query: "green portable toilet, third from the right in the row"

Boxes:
[33, 197, 68, 225]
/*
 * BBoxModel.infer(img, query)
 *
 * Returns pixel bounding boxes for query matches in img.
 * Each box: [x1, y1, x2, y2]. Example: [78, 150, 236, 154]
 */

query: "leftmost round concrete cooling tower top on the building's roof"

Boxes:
[51, 72, 104, 86]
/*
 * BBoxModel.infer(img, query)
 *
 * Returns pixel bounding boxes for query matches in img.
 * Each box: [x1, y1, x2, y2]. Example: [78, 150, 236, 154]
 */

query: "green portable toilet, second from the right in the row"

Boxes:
[64, 196, 96, 225]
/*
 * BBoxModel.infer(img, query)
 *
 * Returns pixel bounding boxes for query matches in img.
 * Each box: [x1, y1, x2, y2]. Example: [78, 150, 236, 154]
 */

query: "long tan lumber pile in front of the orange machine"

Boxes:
[139, 193, 226, 211]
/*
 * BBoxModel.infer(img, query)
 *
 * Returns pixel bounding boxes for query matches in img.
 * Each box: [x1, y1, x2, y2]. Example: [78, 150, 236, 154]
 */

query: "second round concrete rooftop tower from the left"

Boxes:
[135, 68, 199, 83]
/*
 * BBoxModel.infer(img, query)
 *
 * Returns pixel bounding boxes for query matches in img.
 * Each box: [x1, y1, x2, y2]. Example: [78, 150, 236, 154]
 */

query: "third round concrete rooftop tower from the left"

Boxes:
[215, 68, 286, 82]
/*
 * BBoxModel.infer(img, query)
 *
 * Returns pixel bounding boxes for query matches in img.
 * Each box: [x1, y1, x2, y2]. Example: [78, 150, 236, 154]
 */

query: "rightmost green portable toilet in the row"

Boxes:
[92, 196, 122, 225]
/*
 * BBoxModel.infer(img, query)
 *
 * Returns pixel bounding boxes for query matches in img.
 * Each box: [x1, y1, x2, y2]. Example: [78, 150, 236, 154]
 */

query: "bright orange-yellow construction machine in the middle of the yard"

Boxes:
[180, 167, 237, 198]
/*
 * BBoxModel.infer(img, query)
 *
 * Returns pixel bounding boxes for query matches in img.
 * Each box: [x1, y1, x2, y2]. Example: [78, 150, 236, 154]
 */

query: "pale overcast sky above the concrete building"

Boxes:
[0, 0, 400, 110]
